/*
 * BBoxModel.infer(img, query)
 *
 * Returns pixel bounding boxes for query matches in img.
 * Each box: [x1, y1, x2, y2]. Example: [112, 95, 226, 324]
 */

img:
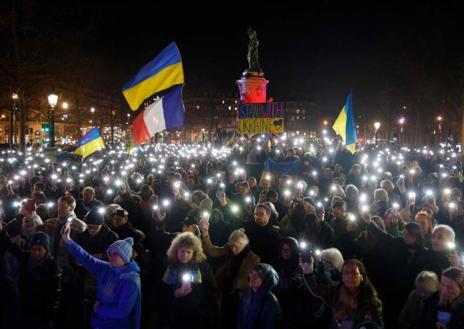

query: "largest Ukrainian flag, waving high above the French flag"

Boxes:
[122, 42, 184, 111]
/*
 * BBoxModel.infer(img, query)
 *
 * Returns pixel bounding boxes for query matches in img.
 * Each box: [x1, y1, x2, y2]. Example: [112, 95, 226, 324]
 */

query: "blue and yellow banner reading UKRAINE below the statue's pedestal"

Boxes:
[238, 102, 285, 134]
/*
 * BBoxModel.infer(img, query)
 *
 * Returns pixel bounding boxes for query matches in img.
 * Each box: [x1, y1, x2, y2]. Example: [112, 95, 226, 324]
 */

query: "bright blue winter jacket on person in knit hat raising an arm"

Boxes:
[67, 240, 142, 329]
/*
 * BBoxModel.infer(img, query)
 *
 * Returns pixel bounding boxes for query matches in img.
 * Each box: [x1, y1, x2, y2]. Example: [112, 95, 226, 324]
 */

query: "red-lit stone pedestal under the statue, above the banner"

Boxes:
[237, 70, 269, 104]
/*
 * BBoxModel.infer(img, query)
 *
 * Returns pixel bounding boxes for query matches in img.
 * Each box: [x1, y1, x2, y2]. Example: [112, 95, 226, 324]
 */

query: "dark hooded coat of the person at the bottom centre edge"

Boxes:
[237, 263, 281, 329]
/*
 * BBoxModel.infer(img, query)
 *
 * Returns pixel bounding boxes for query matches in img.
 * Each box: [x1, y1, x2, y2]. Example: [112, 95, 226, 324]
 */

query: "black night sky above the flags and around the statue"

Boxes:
[3, 1, 464, 118]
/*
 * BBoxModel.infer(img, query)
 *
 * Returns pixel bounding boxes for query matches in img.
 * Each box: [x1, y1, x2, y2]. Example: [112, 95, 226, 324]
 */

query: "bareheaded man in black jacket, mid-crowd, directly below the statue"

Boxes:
[245, 204, 280, 263]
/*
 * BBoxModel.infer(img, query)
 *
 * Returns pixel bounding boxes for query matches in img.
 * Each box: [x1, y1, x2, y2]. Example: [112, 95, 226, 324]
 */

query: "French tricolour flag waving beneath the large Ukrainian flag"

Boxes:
[132, 85, 185, 145]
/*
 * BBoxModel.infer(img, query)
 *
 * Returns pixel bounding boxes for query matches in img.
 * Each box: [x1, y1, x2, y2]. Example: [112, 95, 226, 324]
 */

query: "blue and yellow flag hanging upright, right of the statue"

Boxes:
[332, 92, 358, 153]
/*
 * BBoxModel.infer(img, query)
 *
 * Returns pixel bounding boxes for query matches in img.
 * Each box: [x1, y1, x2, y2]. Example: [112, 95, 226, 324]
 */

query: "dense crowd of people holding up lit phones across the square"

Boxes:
[0, 134, 464, 329]
